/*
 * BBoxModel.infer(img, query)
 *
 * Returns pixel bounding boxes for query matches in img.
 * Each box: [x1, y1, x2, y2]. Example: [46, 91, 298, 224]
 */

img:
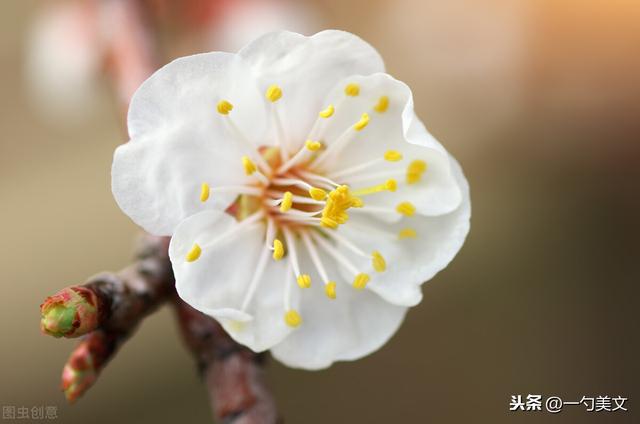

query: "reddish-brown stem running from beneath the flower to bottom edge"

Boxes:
[174, 296, 280, 424]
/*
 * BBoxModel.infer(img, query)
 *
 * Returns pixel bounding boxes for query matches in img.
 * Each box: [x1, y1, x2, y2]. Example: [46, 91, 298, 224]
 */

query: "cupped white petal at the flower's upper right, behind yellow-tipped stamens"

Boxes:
[322, 74, 461, 220]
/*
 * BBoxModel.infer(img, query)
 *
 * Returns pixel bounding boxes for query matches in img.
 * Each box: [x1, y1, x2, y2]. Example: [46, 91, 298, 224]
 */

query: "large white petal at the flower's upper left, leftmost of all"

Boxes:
[112, 53, 266, 235]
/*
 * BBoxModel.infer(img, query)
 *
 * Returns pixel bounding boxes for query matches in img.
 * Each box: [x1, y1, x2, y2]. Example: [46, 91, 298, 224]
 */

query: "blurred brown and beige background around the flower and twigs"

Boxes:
[0, 0, 640, 424]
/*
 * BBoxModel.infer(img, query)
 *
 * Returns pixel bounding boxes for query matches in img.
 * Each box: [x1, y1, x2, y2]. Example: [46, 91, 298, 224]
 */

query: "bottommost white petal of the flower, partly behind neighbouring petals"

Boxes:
[271, 248, 407, 370]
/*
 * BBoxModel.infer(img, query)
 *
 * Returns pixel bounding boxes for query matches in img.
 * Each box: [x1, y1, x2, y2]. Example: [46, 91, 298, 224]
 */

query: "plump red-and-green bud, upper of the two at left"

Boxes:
[40, 286, 98, 337]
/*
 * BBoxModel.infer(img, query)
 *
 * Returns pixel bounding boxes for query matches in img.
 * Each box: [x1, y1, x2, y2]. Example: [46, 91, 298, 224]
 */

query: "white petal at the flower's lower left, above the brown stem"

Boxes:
[169, 211, 298, 352]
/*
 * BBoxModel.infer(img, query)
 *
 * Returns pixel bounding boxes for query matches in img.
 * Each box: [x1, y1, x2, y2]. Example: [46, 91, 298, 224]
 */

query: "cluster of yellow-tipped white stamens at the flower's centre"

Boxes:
[186, 84, 427, 327]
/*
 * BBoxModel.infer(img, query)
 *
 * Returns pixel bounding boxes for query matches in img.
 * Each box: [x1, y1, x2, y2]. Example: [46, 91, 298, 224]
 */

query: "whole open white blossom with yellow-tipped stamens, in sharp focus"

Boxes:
[112, 31, 470, 369]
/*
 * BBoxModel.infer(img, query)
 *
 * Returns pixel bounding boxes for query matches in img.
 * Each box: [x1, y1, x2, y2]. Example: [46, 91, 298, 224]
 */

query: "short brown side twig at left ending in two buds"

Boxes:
[40, 235, 174, 401]
